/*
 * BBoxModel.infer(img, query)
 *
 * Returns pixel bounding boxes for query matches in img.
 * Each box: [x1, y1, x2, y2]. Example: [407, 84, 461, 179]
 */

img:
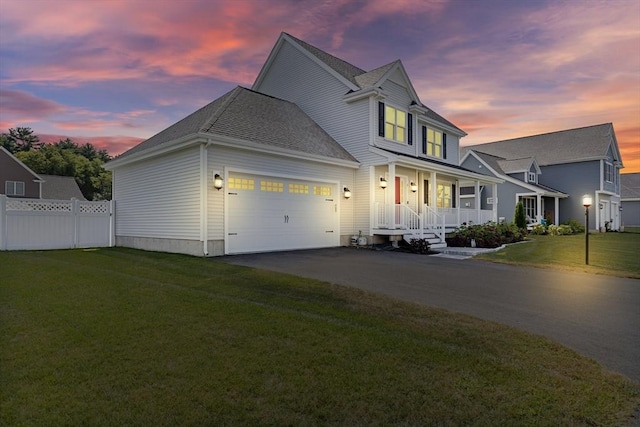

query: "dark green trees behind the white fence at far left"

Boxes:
[0, 127, 111, 200]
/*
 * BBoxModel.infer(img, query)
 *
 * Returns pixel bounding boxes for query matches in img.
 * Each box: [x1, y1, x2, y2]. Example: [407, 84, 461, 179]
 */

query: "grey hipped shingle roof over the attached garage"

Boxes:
[117, 86, 356, 162]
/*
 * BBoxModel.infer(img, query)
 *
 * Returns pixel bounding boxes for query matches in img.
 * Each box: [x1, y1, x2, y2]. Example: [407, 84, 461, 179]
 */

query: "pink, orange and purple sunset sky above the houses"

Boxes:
[0, 0, 640, 173]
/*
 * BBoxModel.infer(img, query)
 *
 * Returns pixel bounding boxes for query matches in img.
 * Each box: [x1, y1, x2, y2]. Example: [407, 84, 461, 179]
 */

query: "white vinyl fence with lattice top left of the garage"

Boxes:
[0, 195, 114, 250]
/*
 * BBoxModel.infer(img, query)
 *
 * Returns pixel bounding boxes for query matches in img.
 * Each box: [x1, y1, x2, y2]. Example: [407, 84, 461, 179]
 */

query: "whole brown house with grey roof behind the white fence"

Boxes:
[0, 147, 86, 200]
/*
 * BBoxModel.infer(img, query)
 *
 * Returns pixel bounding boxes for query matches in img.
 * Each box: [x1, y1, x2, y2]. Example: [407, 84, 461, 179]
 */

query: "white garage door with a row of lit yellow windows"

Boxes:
[225, 173, 340, 254]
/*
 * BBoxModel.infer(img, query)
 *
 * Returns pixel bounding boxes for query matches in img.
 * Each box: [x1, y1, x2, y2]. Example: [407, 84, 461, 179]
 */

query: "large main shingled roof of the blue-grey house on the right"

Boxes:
[461, 123, 622, 166]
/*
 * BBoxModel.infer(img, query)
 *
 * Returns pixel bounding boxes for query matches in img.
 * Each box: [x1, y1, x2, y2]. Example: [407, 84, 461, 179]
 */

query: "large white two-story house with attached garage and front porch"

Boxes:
[105, 33, 502, 255]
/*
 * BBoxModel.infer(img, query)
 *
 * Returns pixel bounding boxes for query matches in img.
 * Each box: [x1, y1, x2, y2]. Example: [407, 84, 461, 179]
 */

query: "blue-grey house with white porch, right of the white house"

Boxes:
[461, 123, 623, 230]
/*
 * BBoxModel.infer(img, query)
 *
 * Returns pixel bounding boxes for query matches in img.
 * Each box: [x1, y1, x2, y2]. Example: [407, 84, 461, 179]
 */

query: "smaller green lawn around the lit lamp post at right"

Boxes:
[476, 228, 640, 279]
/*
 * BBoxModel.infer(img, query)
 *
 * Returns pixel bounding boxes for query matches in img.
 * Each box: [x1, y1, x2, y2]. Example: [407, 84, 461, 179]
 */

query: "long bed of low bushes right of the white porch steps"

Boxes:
[446, 222, 524, 248]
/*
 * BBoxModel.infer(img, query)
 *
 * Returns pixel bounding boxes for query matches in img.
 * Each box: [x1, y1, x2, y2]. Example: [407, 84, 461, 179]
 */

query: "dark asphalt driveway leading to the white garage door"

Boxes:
[225, 248, 640, 382]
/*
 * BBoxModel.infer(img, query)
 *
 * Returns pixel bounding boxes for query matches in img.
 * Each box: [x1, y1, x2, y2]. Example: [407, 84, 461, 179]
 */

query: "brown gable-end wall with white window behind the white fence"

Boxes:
[0, 147, 42, 199]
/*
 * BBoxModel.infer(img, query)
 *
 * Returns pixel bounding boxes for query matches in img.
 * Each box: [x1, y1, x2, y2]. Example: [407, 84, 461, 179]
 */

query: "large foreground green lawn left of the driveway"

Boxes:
[0, 248, 640, 426]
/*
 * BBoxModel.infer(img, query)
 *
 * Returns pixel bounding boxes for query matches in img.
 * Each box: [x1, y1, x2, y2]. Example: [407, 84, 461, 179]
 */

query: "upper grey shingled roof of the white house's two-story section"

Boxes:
[284, 33, 464, 133]
